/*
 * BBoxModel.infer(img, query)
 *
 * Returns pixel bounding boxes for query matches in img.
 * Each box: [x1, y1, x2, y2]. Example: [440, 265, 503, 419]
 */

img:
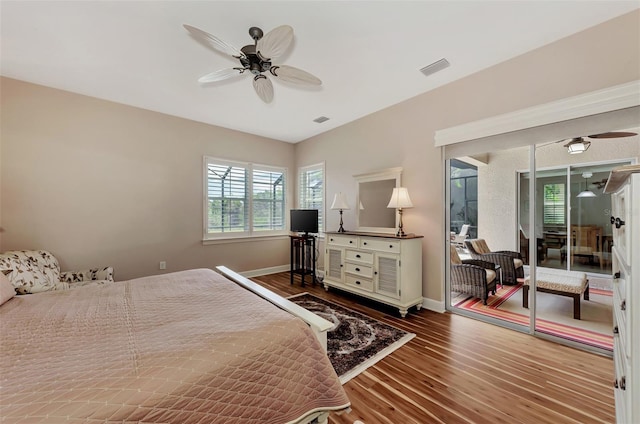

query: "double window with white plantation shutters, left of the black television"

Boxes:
[204, 157, 286, 239]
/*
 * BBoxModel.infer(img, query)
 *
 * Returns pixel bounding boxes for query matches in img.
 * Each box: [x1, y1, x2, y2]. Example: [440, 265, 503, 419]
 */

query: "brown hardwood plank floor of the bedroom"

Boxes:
[253, 272, 615, 424]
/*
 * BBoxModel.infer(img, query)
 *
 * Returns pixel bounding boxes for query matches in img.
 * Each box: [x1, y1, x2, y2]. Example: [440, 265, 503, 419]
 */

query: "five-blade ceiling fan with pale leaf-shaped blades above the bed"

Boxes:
[183, 24, 322, 103]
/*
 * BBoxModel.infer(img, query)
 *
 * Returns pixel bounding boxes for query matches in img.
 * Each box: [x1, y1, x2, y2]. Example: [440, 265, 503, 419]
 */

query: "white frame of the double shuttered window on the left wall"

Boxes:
[202, 156, 289, 241]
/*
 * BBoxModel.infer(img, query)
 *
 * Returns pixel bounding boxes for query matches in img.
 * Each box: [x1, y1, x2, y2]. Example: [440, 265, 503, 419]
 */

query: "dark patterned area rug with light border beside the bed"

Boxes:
[289, 293, 415, 384]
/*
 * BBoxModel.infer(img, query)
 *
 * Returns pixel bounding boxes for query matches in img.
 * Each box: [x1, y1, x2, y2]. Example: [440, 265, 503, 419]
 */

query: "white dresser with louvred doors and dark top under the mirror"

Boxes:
[323, 232, 423, 317]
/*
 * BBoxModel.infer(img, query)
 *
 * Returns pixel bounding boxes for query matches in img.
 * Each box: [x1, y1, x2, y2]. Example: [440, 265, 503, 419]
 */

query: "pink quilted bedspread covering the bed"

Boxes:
[0, 269, 349, 424]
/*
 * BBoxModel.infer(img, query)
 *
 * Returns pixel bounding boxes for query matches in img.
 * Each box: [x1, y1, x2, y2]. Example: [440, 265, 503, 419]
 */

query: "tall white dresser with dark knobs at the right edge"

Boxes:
[605, 165, 640, 424]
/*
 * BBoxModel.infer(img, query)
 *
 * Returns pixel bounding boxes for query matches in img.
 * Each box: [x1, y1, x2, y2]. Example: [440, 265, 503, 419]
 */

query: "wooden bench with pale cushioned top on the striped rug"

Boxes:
[522, 269, 589, 319]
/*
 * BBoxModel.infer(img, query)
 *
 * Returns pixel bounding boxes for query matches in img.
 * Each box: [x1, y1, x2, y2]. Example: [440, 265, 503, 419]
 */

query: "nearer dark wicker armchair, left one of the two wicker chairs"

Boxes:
[451, 246, 496, 305]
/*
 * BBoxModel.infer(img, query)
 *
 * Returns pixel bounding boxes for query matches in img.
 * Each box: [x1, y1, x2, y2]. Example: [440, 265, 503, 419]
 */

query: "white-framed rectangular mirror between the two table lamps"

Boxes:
[354, 168, 402, 233]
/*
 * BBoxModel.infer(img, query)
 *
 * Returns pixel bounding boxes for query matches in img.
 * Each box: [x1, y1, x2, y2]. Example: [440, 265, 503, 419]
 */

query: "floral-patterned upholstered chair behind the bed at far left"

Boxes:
[0, 250, 113, 294]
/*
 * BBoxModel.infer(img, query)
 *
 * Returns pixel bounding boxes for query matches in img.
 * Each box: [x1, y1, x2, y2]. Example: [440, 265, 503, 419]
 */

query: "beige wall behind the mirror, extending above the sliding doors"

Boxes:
[296, 11, 640, 301]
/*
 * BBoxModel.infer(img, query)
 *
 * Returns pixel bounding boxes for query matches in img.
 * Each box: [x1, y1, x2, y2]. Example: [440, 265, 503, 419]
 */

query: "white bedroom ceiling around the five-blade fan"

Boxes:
[0, 0, 640, 143]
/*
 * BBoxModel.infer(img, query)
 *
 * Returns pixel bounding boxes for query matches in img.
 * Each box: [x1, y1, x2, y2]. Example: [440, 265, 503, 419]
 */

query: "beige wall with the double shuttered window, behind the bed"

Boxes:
[0, 78, 295, 280]
